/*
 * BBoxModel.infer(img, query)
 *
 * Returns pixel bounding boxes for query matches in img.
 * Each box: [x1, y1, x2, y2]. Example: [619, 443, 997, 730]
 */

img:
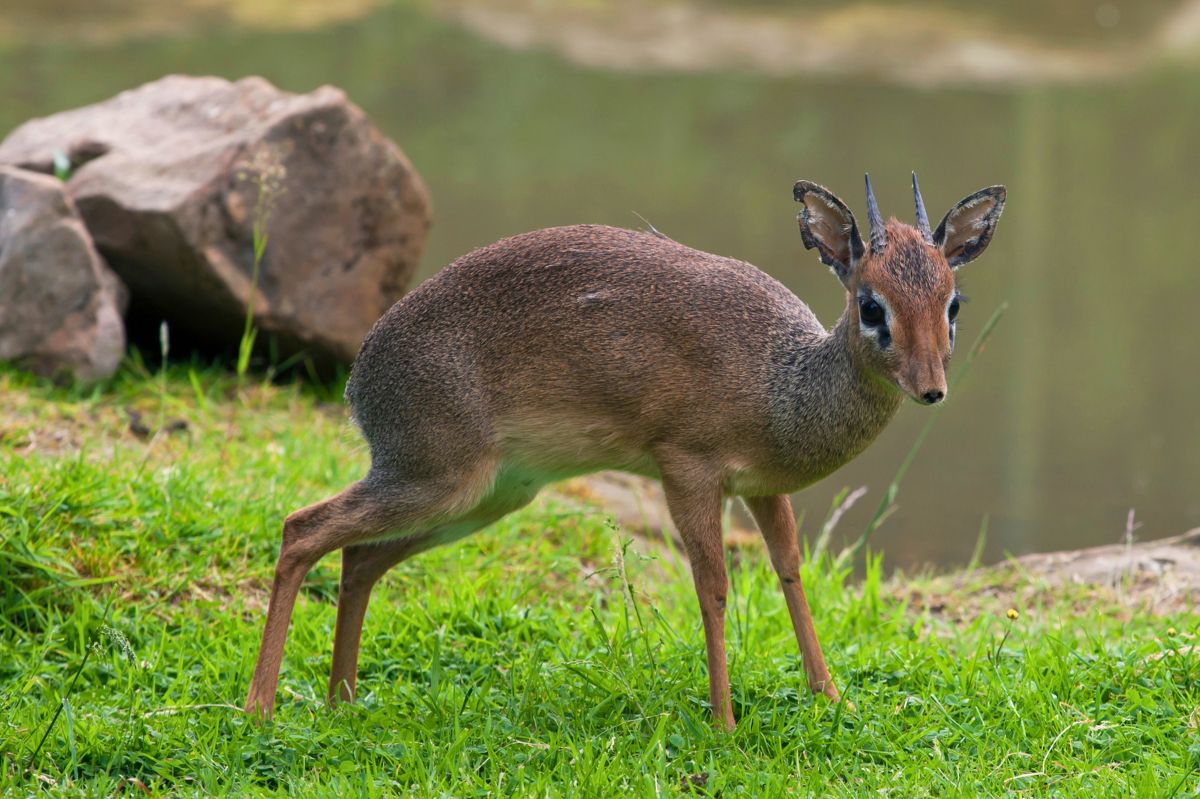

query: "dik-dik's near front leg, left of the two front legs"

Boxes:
[660, 463, 734, 729]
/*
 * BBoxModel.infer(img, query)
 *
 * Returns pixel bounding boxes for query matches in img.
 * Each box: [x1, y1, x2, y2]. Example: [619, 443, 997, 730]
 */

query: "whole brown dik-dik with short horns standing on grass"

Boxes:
[246, 175, 1006, 727]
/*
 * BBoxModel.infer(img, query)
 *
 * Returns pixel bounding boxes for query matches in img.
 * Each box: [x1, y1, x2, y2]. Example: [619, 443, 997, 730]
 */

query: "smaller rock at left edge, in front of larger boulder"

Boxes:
[0, 167, 125, 382]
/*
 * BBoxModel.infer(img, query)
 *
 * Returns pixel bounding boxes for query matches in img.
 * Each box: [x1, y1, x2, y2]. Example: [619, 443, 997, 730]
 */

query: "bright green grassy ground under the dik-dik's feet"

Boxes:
[0, 364, 1200, 798]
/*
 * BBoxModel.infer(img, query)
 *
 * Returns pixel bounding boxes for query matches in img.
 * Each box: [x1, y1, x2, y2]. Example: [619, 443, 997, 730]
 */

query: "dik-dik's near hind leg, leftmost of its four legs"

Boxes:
[246, 476, 484, 717]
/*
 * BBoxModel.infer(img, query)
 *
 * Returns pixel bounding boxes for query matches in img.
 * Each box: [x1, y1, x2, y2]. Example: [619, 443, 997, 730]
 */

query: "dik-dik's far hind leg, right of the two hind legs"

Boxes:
[328, 488, 536, 704]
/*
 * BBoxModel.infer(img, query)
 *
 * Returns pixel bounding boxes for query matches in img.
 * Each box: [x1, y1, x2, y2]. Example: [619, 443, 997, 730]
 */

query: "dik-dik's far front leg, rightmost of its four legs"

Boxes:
[745, 494, 839, 702]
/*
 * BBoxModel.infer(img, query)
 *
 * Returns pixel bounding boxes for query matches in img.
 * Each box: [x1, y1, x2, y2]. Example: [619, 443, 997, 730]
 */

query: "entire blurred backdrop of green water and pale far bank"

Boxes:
[0, 0, 1200, 567]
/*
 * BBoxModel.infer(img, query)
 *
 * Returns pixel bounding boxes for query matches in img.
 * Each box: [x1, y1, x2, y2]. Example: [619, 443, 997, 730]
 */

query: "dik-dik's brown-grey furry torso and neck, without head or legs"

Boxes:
[347, 226, 896, 493]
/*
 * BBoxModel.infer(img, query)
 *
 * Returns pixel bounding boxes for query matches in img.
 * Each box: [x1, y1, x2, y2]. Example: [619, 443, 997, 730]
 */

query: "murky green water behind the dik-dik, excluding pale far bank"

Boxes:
[0, 0, 1200, 567]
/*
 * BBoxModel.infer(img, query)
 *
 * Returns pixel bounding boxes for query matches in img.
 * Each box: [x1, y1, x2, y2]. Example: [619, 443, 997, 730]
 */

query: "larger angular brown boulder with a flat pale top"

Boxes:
[0, 76, 430, 364]
